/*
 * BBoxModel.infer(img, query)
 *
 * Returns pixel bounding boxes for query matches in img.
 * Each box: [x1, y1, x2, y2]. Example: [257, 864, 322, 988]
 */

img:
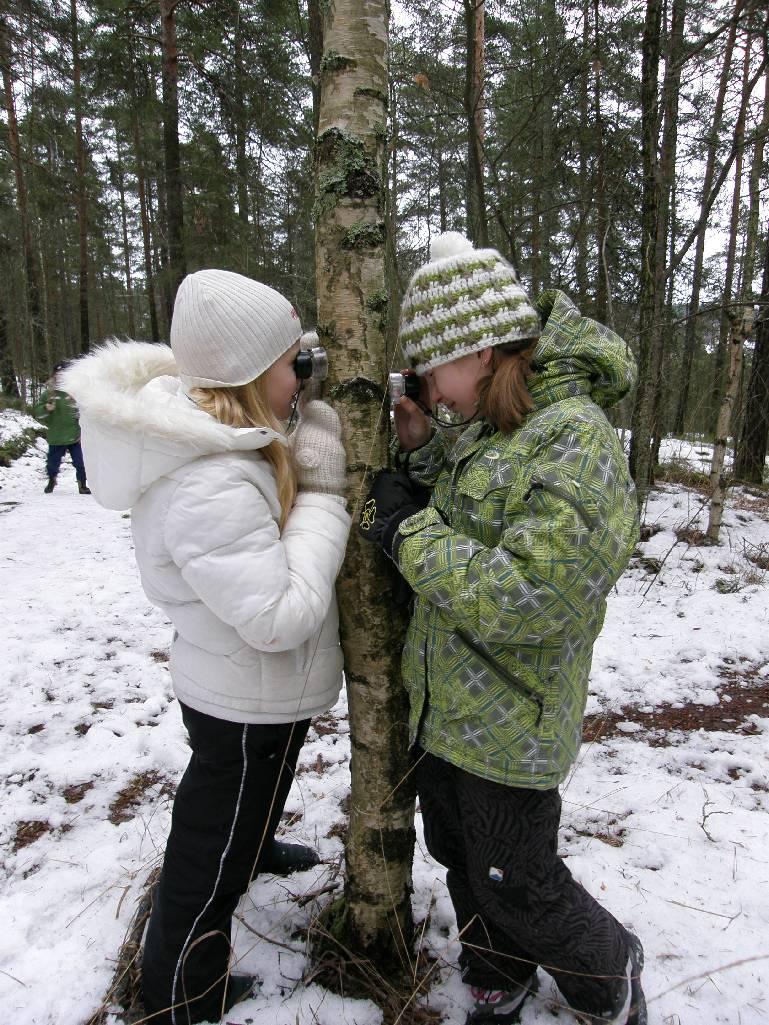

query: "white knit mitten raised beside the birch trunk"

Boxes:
[291, 399, 347, 495]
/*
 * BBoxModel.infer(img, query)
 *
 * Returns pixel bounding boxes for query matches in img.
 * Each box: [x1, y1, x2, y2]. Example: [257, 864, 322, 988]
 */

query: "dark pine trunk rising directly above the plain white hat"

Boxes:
[160, 0, 187, 315]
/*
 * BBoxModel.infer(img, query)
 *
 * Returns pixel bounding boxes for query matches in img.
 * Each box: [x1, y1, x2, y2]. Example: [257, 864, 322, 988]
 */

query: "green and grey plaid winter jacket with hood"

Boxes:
[396, 292, 638, 789]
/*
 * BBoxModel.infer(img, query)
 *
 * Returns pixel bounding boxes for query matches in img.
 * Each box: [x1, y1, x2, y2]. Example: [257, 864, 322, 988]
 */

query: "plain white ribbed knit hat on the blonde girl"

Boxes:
[171, 271, 301, 388]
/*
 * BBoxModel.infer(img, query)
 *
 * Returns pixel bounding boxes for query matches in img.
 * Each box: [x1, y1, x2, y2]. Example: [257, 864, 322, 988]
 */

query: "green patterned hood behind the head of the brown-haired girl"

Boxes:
[529, 289, 637, 409]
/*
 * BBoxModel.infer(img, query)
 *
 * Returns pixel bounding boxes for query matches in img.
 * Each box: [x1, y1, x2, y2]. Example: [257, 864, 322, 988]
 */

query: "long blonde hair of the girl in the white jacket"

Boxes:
[190, 374, 296, 530]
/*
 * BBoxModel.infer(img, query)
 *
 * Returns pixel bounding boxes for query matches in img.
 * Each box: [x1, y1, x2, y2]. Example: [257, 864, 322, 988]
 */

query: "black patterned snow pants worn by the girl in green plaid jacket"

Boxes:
[415, 748, 629, 1014]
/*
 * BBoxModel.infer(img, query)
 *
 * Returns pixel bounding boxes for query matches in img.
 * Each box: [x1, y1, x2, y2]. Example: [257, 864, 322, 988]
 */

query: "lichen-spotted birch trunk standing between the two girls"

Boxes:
[316, 0, 414, 972]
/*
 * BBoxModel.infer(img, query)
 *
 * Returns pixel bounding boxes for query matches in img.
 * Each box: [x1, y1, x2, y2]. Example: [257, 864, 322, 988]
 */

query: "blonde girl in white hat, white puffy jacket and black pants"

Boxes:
[66, 271, 350, 1025]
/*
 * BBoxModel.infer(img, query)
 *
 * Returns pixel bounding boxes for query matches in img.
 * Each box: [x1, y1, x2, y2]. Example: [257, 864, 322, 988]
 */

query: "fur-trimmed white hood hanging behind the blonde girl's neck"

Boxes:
[60, 340, 286, 509]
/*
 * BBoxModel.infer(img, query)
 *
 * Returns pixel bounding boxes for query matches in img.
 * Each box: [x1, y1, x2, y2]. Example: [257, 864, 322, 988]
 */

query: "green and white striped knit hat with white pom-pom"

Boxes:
[399, 232, 540, 374]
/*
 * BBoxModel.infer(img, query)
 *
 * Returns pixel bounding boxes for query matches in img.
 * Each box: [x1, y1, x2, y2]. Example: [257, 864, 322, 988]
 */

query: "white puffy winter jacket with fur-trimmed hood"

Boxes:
[63, 342, 350, 723]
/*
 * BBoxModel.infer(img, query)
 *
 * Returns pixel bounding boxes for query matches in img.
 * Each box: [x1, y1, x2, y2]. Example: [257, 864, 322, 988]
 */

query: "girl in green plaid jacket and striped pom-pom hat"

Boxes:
[359, 233, 647, 1025]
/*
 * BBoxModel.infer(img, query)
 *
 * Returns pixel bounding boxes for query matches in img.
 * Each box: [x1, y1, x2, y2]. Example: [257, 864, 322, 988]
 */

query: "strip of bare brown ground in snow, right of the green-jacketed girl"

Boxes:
[582, 664, 769, 747]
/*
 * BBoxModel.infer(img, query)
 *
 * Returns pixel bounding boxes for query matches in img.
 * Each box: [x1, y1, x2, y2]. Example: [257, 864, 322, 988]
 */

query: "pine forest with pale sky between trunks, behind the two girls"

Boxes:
[0, 0, 769, 498]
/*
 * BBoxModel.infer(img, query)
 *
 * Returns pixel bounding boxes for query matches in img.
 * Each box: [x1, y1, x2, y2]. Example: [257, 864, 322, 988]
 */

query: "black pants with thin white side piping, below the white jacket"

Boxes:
[141, 704, 310, 1025]
